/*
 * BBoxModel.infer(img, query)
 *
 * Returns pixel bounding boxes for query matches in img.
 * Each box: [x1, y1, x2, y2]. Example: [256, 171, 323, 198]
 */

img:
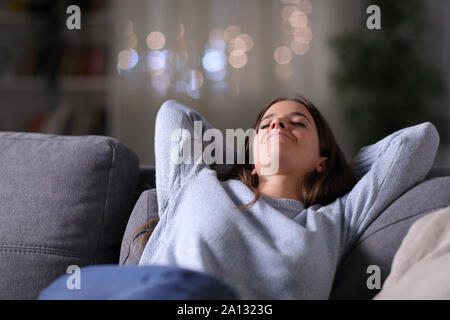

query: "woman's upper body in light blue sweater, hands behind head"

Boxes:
[140, 96, 439, 299]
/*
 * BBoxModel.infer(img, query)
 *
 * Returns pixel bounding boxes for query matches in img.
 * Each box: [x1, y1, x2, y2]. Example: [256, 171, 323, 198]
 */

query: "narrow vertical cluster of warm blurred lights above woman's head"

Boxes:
[273, 0, 313, 79]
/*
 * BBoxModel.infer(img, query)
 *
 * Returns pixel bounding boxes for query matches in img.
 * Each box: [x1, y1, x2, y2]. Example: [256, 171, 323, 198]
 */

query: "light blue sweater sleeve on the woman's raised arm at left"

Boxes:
[155, 100, 229, 217]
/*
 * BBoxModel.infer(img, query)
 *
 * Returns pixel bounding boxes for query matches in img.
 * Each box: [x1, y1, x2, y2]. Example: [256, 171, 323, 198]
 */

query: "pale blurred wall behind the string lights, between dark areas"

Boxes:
[114, 0, 364, 164]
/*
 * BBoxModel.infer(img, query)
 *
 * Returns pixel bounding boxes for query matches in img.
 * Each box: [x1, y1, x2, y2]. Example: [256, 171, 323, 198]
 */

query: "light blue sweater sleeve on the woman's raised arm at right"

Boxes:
[344, 122, 439, 243]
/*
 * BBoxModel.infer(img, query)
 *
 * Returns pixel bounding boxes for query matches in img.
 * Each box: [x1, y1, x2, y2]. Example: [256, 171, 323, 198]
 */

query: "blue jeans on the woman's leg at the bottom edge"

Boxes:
[38, 265, 237, 300]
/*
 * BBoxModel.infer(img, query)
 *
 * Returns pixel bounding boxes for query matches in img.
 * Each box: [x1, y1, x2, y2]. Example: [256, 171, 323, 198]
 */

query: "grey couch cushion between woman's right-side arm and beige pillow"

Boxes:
[330, 177, 450, 299]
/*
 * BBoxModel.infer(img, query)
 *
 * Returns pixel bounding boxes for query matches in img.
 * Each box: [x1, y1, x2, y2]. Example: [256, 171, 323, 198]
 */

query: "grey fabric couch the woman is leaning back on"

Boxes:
[0, 132, 450, 299]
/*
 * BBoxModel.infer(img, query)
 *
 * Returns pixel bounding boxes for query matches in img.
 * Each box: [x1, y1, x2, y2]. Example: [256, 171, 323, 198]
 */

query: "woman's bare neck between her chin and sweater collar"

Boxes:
[258, 175, 302, 201]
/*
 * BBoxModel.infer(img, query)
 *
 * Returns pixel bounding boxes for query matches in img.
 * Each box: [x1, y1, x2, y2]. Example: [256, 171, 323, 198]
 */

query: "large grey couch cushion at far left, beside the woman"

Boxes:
[0, 132, 139, 299]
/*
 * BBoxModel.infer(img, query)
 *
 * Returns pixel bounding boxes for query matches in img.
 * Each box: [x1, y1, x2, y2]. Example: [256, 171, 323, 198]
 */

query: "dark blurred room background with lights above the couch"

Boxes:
[0, 0, 450, 165]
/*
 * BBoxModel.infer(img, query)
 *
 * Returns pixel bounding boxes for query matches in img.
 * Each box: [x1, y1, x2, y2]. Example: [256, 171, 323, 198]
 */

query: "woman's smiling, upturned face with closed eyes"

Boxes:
[253, 100, 326, 178]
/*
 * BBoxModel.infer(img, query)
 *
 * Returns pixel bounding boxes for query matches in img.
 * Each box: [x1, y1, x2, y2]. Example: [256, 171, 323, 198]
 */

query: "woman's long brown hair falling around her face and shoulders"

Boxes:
[130, 95, 356, 252]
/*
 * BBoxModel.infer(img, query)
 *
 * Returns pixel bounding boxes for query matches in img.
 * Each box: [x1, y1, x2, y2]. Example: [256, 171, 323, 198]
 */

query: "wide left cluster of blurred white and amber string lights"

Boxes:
[117, 22, 254, 99]
